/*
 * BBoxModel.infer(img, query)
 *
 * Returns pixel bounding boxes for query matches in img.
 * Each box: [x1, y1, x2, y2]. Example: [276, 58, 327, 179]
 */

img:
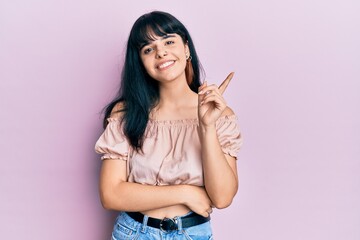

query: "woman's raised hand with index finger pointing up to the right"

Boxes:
[198, 72, 234, 126]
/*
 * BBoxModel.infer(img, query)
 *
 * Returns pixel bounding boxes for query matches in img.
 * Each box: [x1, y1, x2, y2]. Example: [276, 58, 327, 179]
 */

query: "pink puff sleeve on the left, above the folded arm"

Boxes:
[95, 118, 129, 161]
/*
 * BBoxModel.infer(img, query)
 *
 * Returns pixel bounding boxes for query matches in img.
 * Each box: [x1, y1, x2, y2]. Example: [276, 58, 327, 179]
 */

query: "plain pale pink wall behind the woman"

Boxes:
[0, 0, 360, 240]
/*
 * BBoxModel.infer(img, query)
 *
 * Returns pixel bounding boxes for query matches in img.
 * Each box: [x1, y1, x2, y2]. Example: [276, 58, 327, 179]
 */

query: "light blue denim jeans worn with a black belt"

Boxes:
[112, 212, 213, 240]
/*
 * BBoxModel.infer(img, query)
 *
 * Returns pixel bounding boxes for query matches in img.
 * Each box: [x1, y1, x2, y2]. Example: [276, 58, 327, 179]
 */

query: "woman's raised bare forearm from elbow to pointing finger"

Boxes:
[199, 74, 238, 208]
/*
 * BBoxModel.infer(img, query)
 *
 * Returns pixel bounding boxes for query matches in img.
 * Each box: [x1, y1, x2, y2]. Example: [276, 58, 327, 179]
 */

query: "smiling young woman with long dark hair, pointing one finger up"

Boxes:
[95, 11, 241, 240]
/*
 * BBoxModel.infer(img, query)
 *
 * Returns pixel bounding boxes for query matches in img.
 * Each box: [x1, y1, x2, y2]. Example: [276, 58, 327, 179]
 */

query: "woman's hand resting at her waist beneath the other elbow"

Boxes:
[184, 185, 213, 217]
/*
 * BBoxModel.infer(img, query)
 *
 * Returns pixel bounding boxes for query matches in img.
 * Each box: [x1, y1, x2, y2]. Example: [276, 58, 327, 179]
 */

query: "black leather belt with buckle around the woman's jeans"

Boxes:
[126, 212, 210, 232]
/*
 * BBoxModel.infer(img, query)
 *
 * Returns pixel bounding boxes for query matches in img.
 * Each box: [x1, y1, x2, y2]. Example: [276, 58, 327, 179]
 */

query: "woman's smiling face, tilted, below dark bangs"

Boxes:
[140, 33, 189, 82]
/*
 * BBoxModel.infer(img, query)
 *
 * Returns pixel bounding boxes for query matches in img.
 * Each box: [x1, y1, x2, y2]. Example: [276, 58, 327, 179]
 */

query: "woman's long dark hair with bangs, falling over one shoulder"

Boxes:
[104, 11, 202, 151]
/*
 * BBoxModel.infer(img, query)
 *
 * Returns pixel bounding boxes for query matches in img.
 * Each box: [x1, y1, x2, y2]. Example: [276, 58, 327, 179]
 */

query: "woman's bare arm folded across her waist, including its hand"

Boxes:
[100, 156, 211, 216]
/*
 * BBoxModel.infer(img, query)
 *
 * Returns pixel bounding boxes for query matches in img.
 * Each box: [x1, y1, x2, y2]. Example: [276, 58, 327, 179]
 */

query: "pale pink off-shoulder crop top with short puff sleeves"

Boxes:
[95, 115, 242, 186]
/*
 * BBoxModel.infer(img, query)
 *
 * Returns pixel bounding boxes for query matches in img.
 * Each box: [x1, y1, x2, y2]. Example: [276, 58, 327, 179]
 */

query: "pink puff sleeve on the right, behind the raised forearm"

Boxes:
[216, 115, 242, 158]
